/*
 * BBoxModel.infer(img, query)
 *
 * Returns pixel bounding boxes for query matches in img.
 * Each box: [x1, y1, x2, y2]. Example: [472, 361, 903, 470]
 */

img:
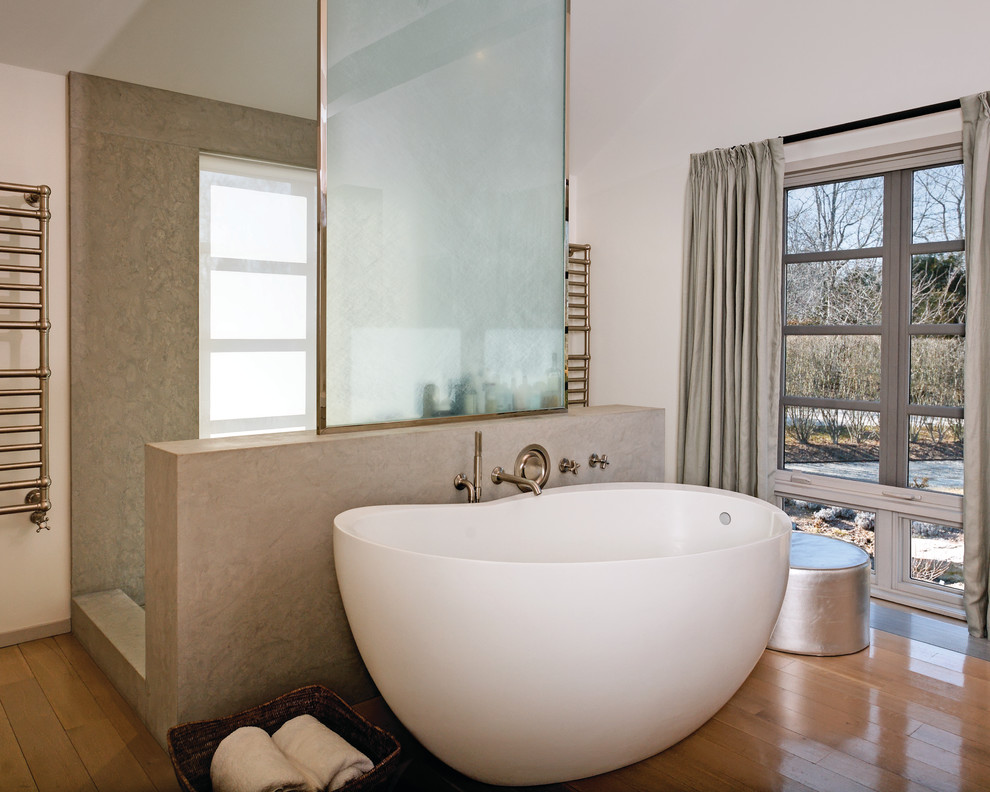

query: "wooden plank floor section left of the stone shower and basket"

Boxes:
[0, 635, 179, 792]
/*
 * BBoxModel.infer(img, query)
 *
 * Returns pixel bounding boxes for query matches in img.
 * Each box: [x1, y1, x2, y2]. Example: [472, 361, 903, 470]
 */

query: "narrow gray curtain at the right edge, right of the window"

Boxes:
[962, 93, 990, 638]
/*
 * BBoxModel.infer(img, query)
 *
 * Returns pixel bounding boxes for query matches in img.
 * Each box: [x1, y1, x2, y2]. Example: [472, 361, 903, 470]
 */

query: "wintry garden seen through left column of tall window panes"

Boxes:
[784, 177, 884, 480]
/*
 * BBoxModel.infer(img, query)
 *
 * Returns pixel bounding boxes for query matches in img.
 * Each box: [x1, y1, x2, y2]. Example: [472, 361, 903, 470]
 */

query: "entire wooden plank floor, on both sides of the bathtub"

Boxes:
[0, 630, 990, 792]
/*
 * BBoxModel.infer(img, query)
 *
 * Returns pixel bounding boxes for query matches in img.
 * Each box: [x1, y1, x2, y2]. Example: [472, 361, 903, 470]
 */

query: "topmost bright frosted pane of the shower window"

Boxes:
[210, 184, 309, 264]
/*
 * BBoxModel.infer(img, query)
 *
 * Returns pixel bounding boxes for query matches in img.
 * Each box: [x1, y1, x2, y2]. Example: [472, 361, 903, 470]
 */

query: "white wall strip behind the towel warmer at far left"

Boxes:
[0, 64, 70, 646]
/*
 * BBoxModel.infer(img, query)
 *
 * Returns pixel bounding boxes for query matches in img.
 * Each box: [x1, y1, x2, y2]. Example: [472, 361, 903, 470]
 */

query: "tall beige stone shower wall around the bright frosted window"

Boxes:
[70, 73, 319, 604]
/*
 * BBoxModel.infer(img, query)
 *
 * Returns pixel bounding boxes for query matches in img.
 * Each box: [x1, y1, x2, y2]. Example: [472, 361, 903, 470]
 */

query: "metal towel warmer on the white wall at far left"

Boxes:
[0, 182, 51, 531]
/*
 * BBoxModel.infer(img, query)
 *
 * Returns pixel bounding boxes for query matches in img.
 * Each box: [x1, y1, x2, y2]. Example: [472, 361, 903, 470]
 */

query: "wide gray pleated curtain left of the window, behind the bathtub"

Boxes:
[677, 138, 784, 500]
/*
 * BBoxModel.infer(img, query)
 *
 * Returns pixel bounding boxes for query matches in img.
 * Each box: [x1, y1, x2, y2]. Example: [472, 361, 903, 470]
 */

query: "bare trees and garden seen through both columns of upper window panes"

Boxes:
[783, 164, 966, 491]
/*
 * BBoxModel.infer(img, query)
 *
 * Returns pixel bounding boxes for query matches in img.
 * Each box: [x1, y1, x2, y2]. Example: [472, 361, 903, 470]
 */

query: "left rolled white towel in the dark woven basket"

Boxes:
[210, 726, 317, 792]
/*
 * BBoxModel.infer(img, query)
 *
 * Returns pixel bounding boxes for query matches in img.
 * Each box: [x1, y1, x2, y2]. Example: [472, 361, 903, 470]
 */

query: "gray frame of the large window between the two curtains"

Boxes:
[774, 142, 965, 618]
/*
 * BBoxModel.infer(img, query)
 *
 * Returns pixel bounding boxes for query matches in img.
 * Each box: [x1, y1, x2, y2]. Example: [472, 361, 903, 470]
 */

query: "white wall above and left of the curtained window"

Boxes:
[569, 0, 990, 479]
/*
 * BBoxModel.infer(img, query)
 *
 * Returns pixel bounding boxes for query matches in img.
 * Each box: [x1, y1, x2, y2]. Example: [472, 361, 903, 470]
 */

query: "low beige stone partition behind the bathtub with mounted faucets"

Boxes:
[145, 406, 664, 741]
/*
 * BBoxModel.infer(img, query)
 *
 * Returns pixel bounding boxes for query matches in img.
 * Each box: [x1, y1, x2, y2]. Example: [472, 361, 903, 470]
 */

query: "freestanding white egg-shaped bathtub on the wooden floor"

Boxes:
[333, 483, 791, 785]
